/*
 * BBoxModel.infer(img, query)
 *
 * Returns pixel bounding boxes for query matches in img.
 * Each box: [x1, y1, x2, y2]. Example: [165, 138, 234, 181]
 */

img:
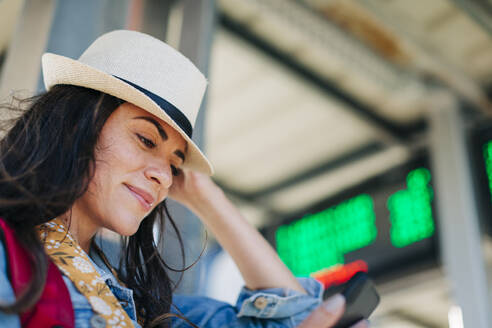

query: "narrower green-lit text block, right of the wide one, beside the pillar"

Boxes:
[388, 168, 435, 247]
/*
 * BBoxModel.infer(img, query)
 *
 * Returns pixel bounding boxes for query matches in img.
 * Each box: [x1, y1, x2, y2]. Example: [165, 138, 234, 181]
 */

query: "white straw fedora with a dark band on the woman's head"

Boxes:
[42, 30, 213, 175]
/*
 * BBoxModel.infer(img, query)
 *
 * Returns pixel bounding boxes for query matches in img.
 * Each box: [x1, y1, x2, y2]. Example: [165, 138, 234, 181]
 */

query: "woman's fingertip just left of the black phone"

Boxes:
[297, 294, 346, 328]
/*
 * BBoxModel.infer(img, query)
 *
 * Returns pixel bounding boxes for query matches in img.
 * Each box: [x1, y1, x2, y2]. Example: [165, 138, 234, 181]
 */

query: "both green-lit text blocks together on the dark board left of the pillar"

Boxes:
[275, 167, 436, 276]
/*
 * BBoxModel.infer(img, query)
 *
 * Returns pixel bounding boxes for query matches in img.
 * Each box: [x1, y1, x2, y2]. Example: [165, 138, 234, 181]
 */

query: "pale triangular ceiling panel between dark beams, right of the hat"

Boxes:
[206, 30, 378, 192]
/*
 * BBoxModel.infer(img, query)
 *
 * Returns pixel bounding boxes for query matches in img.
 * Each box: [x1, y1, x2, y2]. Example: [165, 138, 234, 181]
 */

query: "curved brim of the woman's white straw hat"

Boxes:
[42, 53, 213, 175]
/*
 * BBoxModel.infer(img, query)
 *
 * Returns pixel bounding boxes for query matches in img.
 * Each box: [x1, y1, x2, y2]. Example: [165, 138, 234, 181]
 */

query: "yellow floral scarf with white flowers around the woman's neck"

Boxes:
[38, 218, 133, 328]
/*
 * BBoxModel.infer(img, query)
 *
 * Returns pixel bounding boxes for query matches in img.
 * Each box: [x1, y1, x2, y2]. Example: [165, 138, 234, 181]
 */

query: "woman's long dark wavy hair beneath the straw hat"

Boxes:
[0, 85, 194, 327]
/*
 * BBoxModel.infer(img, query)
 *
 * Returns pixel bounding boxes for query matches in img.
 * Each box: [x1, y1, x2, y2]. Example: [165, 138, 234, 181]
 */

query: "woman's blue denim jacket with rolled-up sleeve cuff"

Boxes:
[0, 242, 323, 328]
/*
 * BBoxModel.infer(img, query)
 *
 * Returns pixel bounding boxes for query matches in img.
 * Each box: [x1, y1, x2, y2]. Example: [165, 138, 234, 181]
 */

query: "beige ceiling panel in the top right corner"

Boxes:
[358, 0, 492, 82]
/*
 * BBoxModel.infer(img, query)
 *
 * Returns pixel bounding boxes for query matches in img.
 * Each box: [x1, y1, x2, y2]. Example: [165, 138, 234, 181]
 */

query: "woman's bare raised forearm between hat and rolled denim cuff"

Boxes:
[169, 170, 306, 293]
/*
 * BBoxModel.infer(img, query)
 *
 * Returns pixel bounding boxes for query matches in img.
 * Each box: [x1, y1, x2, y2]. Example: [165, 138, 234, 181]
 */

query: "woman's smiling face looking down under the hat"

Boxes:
[72, 103, 186, 236]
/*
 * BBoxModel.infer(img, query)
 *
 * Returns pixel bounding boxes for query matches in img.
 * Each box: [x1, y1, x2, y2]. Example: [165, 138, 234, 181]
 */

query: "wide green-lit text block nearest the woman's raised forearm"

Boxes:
[276, 194, 377, 276]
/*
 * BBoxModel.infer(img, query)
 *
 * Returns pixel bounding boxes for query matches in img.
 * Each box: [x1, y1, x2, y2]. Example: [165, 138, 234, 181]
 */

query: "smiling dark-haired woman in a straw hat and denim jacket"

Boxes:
[0, 31, 368, 327]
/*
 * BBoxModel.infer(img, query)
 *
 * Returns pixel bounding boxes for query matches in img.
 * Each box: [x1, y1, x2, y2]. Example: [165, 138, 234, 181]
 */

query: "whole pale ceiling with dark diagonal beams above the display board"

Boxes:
[207, 0, 492, 225]
